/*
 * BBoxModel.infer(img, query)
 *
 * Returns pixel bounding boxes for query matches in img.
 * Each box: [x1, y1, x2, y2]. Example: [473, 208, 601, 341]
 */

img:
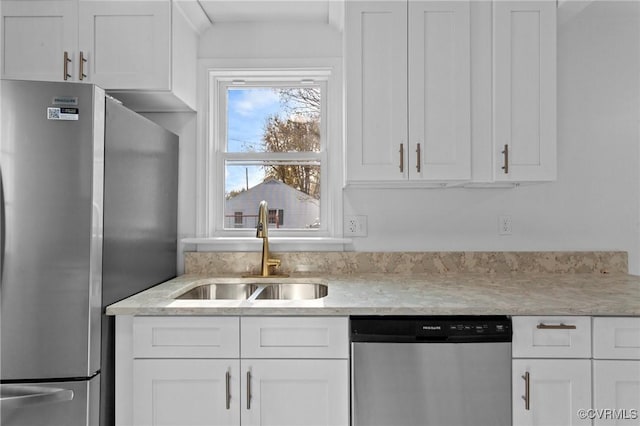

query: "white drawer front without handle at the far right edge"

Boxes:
[593, 317, 640, 359]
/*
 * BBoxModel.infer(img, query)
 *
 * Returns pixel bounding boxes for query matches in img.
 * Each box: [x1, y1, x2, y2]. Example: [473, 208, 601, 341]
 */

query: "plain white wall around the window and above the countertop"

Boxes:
[3, 2, 640, 426]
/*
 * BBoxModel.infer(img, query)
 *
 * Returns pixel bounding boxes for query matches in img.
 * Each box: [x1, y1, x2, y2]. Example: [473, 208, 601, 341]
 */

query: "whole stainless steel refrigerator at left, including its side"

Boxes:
[0, 80, 178, 426]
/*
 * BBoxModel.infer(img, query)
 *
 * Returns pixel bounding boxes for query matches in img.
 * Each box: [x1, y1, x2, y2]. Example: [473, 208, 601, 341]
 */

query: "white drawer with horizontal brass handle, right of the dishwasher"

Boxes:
[512, 316, 591, 358]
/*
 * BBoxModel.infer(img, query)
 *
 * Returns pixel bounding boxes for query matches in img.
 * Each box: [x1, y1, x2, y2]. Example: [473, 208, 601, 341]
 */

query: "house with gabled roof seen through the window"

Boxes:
[224, 179, 320, 229]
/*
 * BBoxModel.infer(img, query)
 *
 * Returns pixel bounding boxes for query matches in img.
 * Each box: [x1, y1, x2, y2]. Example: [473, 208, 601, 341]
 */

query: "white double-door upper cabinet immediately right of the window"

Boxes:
[345, 1, 471, 184]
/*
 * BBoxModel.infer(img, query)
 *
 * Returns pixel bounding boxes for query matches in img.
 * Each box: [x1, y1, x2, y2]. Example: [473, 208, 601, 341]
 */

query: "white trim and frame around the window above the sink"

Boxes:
[192, 58, 348, 250]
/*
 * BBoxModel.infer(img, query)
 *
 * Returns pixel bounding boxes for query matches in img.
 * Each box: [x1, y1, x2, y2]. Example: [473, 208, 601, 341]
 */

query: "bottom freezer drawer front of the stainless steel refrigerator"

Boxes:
[0, 376, 100, 426]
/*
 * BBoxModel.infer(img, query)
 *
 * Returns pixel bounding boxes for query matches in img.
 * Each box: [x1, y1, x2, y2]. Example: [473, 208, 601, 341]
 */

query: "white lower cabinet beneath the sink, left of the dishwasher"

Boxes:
[116, 316, 349, 426]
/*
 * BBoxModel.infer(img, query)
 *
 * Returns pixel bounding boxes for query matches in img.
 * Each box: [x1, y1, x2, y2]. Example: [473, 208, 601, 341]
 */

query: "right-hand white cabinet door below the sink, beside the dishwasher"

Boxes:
[241, 360, 349, 426]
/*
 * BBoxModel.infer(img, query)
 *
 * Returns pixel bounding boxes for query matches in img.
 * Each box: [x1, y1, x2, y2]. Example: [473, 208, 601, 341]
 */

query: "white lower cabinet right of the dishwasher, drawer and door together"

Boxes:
[512, 316, 591, 426]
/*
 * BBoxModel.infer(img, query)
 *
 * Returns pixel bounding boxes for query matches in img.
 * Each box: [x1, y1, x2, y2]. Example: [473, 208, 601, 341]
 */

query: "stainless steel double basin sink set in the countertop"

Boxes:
[176, 282, 329, 301]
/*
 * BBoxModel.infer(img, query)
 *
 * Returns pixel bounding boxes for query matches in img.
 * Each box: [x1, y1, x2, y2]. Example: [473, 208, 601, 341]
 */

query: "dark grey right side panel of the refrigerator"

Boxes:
[101, 99, 178, 425]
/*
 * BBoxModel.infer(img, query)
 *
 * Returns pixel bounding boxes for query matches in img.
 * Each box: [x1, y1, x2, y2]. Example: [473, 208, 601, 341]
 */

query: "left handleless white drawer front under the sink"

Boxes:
[133, 317, 240, 358]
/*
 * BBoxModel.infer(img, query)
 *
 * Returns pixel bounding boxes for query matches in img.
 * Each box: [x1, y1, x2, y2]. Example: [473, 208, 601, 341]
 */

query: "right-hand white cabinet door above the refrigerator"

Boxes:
[78, 0, 172, 90]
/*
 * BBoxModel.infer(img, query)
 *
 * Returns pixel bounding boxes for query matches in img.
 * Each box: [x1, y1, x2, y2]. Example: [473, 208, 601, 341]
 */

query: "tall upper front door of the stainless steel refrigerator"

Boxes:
[0, 80, 104, 380]
